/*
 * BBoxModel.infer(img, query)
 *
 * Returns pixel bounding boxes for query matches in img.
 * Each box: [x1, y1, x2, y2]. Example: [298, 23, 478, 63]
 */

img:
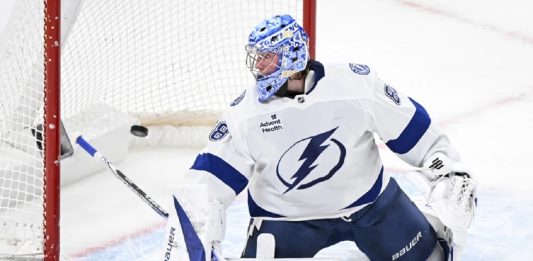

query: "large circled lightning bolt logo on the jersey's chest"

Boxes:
[276, 127, 346, 193]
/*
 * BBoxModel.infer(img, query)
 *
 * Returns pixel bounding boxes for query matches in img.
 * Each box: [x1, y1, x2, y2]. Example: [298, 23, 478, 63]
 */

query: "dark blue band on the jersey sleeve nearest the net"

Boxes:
[191, 153, 248, 195]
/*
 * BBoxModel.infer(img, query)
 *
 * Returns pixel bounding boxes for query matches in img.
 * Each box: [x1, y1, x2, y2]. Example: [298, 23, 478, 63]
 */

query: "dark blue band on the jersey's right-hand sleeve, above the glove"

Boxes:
[386, 98, 431, 154]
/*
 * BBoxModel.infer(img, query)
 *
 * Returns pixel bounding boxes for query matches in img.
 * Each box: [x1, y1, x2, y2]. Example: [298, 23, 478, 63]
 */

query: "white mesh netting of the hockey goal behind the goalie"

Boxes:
[0, 0, 314, 260]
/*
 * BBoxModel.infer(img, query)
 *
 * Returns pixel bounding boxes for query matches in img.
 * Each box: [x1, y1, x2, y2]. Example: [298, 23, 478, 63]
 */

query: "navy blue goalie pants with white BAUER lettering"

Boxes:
[242, 178, 448, 260]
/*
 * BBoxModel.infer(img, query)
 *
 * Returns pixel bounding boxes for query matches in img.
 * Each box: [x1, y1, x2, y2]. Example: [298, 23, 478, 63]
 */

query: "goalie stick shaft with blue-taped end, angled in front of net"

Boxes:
[76, 135, 168, 219]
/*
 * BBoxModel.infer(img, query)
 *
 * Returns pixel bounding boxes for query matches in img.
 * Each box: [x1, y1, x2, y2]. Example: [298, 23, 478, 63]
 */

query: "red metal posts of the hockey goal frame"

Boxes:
[43, 0, 317, 261]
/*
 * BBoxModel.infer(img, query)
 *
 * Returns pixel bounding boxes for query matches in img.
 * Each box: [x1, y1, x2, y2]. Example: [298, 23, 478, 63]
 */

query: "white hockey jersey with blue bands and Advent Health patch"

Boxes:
[188, 61, 458, 220]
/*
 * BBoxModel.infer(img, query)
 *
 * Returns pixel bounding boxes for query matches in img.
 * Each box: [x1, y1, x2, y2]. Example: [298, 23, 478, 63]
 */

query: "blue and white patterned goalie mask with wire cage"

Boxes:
[246, 15, 309, 102]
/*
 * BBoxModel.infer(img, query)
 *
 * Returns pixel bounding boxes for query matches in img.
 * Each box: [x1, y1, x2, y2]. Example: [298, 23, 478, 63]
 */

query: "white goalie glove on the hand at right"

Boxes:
[421, 153, 477, 233]
